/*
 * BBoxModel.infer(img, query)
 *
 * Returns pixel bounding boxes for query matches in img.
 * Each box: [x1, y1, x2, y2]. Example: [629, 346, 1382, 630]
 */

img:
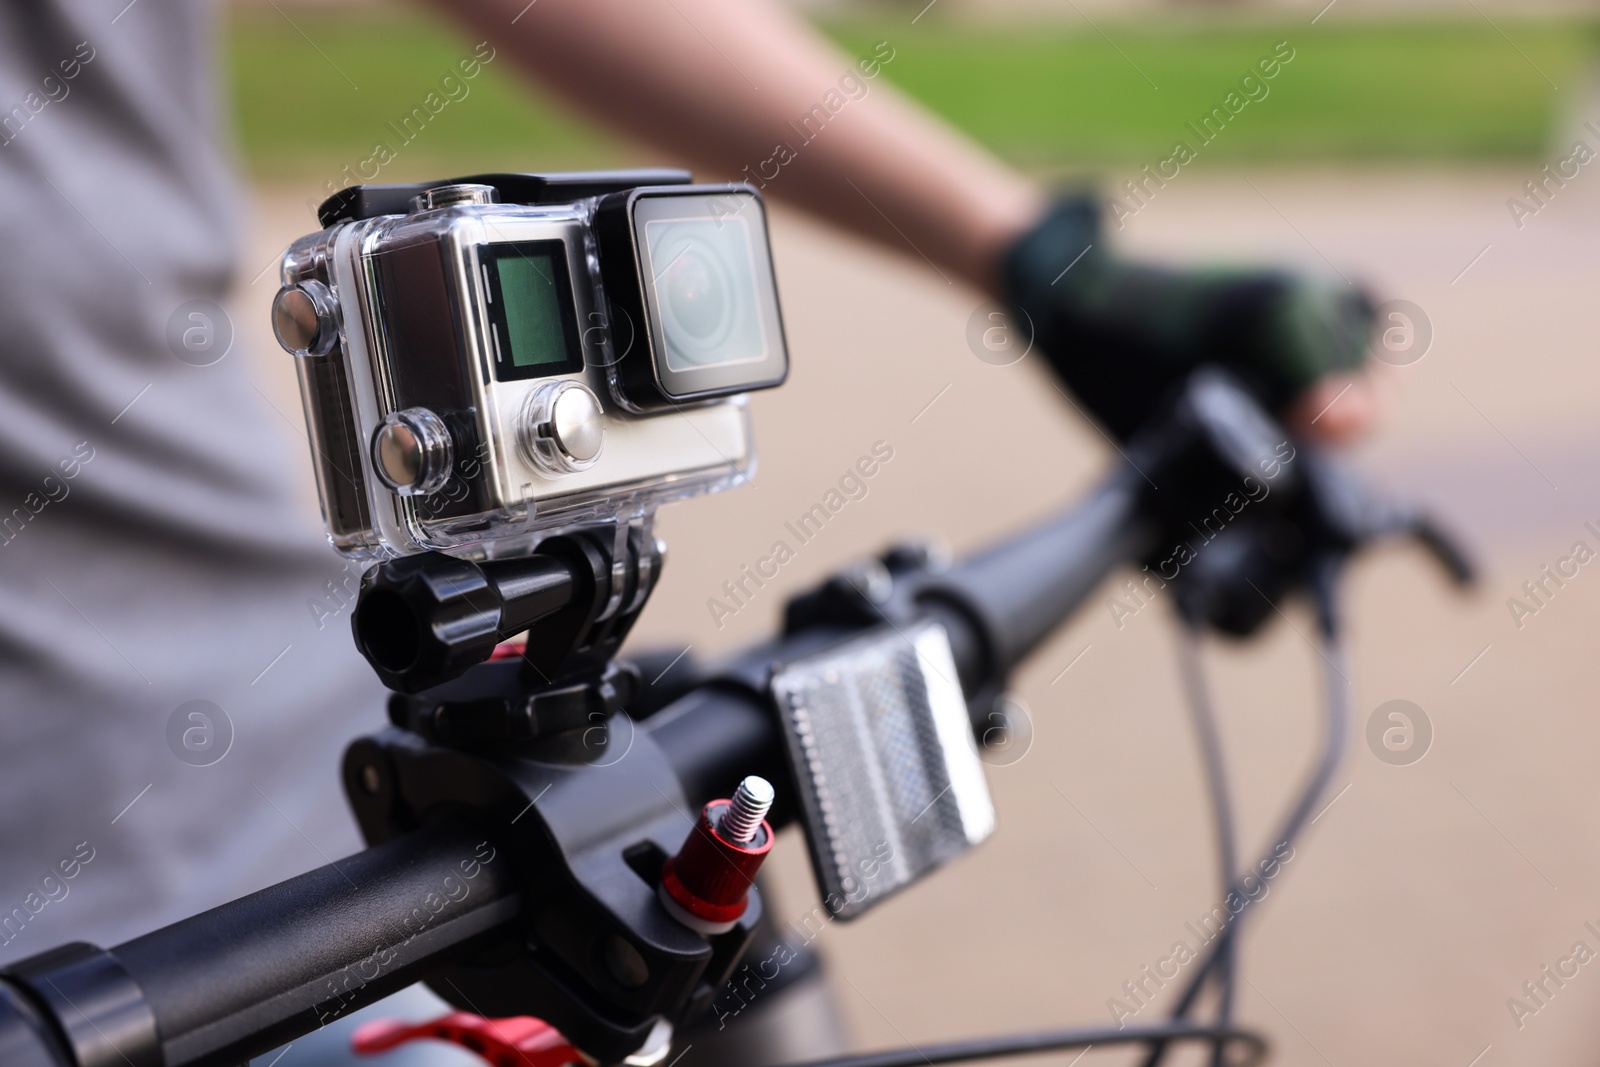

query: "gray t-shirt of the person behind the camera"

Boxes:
[0, 0, 382, 963]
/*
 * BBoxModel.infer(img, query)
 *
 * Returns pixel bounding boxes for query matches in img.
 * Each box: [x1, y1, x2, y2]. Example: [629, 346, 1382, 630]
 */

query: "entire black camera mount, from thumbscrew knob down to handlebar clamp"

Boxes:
[344, 518, 770, 1064]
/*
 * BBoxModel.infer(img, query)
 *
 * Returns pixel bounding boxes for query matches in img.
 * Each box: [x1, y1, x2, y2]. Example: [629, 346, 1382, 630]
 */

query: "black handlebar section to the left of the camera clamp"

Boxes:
[0, 825, 518, 1067]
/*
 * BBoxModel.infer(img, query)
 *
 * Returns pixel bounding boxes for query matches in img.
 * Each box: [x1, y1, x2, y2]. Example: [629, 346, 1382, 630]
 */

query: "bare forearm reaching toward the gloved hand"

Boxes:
[419, 0, 1045, 294]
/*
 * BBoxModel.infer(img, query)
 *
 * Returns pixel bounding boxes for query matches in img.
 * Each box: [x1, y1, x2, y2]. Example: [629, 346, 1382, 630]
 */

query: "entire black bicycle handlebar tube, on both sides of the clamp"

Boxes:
[0, 374, 1465, 1067]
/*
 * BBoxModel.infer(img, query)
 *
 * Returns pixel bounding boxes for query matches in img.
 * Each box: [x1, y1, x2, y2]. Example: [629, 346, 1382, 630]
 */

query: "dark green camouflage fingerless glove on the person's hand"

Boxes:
[1002, 197, 1373, 440]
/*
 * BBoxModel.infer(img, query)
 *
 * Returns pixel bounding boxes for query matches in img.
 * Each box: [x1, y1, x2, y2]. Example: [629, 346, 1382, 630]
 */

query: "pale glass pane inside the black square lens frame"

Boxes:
[648, 216, 766, 370]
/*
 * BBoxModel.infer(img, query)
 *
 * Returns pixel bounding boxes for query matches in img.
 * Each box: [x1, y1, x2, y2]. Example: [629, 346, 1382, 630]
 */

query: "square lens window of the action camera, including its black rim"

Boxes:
[634, 190, 789, 397]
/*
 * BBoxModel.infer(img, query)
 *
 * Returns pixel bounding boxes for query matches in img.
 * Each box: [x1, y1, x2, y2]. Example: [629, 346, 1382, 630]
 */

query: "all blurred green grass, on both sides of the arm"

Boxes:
[227, 5, 1597, 184]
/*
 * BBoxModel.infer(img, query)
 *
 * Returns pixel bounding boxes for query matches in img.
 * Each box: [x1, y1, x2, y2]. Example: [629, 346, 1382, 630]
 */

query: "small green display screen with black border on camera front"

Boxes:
[483, 242, 582, 381]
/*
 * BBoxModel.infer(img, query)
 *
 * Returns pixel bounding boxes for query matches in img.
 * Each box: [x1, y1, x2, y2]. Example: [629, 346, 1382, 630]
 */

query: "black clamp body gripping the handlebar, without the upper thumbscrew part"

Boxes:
[344, 662, 762, 1062]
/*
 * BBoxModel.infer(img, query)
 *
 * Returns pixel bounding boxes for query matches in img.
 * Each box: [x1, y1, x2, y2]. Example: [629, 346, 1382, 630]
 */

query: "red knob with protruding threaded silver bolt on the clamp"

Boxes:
[659, 774, 774, 934]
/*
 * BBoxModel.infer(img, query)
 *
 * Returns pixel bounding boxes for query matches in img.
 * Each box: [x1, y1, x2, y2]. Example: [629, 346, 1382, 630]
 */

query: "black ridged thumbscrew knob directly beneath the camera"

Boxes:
[350, 552, 574, 693]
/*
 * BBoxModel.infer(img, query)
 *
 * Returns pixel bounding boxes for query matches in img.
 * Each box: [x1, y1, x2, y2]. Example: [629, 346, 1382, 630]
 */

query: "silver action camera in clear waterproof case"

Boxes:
[272, 170, 789, 558]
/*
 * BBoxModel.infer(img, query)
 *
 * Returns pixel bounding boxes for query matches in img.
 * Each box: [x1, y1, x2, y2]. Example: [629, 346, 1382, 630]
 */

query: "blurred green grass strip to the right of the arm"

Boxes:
[840, 22, 1595, 165]
